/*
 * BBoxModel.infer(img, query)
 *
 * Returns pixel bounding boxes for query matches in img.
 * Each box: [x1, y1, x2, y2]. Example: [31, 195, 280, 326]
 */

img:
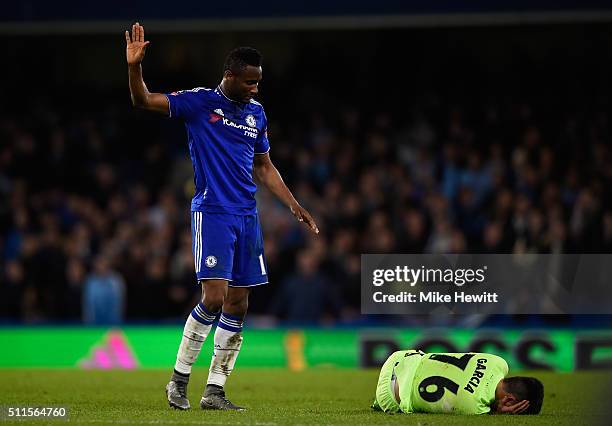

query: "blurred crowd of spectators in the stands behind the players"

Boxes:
[0, 95, 612, 324]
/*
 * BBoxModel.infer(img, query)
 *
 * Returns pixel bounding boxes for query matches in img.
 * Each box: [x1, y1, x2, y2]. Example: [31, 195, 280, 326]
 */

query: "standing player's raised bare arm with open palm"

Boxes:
[125, 22, 170, 115]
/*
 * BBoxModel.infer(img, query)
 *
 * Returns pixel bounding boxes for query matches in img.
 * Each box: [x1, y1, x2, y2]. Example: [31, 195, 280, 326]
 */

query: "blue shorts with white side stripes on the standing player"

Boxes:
[191, 211, 268, 287]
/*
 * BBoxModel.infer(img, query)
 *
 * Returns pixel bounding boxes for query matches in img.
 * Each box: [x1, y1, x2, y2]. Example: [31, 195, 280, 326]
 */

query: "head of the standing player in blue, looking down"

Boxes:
[223, 47, 263, 102]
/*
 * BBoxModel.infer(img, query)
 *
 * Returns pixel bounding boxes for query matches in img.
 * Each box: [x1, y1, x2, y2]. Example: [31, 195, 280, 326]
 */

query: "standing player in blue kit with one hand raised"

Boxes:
[125, 23, 319, 410]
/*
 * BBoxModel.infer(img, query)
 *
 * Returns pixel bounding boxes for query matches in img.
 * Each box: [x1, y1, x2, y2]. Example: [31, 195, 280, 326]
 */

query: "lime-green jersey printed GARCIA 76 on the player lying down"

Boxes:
[410, 353, 508, 414]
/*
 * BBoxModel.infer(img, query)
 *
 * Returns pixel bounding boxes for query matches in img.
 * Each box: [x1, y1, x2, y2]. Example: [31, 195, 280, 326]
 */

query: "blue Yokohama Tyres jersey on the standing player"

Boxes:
[166, 87, 270, 215]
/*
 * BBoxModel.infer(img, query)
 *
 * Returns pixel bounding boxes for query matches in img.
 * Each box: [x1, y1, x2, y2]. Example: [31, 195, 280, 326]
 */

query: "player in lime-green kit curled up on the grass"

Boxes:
[372, 350, 544, 414]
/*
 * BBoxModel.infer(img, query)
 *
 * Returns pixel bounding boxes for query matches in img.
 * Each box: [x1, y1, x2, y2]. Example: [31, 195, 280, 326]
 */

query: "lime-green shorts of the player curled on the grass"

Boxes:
[372, 349, 422, 413]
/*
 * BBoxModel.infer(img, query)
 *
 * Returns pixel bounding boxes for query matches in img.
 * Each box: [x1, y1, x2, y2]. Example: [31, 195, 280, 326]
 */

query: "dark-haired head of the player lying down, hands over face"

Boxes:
[495, 376, 544, 414]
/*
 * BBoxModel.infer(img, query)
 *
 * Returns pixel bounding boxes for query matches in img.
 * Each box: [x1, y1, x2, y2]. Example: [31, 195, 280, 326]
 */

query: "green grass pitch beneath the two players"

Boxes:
[0, 368, 612, 426]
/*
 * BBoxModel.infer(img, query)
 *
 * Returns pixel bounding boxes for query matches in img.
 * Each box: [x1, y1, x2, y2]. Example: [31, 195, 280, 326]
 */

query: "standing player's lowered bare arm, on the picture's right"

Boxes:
[253, 152, 319, 234]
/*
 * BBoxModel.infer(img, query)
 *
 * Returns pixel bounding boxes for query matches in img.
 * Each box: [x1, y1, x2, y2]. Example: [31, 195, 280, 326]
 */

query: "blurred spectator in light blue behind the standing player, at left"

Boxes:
[83, 254, 125, 325]
